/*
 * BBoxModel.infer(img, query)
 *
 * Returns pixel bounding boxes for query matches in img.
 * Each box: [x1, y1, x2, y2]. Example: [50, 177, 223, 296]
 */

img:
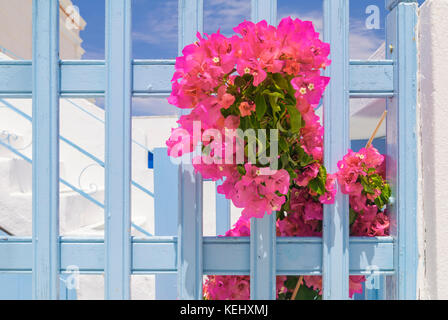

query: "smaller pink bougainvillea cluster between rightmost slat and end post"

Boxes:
[336, 147, 389, 237]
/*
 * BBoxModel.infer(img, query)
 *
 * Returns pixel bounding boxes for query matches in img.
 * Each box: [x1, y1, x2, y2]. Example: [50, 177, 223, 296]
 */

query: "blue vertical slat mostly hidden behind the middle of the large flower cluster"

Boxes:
[250, 0, 277, 300]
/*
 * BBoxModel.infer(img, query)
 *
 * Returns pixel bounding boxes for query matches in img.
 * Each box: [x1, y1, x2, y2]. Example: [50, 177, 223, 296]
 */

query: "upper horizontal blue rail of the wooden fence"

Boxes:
[0, 60, 393, 97]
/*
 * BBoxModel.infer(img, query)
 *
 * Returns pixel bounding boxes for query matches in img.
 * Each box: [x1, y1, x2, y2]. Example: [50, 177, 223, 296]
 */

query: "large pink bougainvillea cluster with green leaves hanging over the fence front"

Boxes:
[167, 18, 334, 222]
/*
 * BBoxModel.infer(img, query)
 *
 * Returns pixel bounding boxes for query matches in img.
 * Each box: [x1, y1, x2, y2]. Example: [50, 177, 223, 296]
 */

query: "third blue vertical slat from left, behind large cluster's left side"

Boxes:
[177, 0, 203, 300]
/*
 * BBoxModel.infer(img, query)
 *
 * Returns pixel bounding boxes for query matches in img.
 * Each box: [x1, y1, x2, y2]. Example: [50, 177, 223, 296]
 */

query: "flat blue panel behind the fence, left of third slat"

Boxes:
[152, 148, 180, 300]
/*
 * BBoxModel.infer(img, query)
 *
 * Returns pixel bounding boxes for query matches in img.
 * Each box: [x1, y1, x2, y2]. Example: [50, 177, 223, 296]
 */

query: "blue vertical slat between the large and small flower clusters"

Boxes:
[322, 0, 350, 299]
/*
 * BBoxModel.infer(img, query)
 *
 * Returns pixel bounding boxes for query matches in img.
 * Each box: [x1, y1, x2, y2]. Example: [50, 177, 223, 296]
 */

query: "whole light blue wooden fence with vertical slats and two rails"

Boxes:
[0, 0, 417, 299]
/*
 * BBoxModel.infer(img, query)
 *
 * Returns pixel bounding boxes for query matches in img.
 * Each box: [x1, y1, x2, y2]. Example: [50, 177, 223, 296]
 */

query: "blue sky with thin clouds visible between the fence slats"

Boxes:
[72, 0, 424, 115]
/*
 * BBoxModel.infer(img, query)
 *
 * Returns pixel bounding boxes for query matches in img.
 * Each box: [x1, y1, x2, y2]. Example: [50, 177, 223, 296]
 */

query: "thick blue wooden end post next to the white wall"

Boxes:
[386, 3, 418, 299]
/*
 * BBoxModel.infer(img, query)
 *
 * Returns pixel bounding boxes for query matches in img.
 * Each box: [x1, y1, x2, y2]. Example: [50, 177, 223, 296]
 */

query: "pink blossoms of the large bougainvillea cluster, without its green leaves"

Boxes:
[167, 17, 334, 217]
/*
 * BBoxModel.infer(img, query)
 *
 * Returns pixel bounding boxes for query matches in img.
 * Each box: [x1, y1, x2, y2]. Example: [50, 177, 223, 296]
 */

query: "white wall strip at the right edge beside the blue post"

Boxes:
[418, 0, 448, 299]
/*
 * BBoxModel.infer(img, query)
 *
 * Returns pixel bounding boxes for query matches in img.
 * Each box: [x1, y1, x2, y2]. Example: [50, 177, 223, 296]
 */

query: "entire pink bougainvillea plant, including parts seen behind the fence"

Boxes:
[166, 17, 390, 299]
